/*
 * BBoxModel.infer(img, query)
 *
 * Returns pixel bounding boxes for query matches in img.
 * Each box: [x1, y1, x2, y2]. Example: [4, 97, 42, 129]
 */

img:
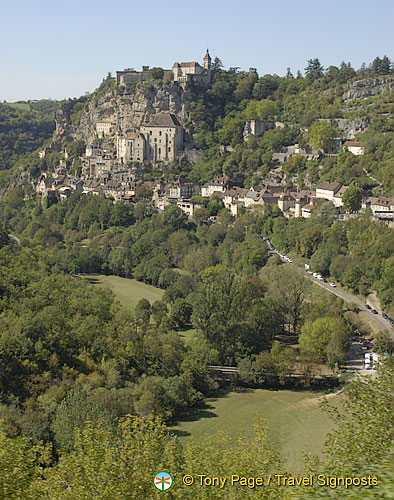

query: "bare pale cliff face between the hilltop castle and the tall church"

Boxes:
[78, 83, 184, 143]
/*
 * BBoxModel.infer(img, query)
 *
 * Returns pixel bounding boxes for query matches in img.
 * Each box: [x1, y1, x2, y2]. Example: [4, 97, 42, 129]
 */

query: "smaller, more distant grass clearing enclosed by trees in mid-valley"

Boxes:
[83, 274, 164, 308]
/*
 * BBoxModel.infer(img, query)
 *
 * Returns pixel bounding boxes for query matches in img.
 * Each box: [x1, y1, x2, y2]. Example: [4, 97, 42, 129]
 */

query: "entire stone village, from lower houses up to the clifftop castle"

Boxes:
[23, 50, 394, 224]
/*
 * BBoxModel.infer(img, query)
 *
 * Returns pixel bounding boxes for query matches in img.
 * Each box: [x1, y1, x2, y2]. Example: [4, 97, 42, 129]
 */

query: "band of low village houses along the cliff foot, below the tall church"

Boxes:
[34, 150, 394, 220]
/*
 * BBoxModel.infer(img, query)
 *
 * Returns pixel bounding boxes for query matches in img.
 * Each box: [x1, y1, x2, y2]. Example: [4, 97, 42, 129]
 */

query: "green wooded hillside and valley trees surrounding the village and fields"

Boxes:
[0, 52, 394, 500]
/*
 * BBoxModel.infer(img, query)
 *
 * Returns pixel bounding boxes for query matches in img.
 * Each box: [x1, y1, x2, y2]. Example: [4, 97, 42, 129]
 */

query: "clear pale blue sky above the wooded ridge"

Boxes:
[0, 0, 394, 102]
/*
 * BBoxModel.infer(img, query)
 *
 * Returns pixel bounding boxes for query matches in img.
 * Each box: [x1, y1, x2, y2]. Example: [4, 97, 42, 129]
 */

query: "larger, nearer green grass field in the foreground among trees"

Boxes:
[173, 389, 339, 473]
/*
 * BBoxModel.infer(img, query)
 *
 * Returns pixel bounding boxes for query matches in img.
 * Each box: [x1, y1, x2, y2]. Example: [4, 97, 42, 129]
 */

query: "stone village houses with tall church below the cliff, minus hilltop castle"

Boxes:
[33, 113, 394, 225]
